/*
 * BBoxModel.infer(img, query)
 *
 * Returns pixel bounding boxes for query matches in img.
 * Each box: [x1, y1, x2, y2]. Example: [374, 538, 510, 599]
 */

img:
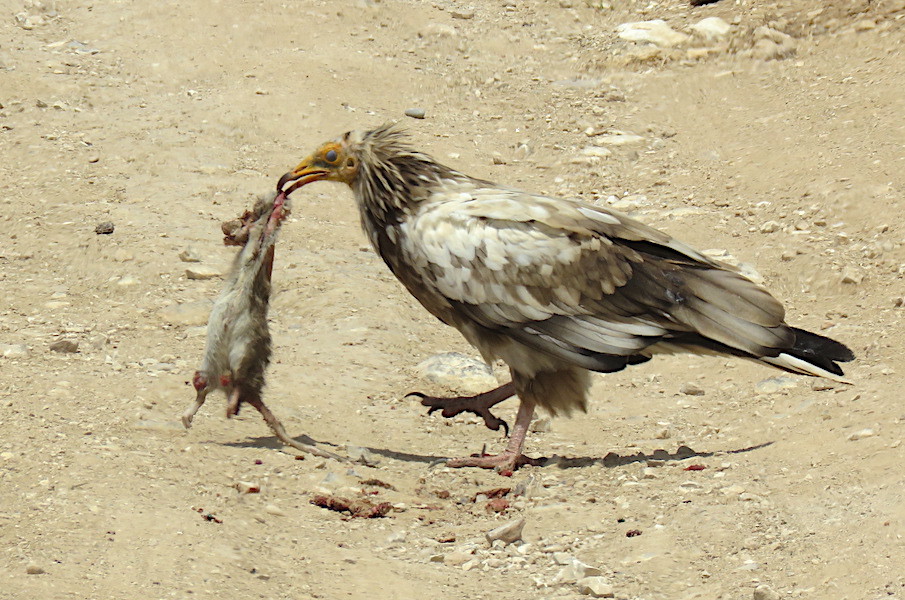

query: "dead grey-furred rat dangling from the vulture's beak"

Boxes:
[182, 193, 344, 460]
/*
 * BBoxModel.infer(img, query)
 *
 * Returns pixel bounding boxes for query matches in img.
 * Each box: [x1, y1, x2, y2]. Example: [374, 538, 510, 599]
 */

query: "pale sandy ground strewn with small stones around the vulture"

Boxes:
[0, 0, 905, 600]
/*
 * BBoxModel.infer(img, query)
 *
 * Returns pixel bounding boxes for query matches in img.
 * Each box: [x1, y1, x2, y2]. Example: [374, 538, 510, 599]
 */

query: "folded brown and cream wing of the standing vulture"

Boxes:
[401, 183, 794, 368]
